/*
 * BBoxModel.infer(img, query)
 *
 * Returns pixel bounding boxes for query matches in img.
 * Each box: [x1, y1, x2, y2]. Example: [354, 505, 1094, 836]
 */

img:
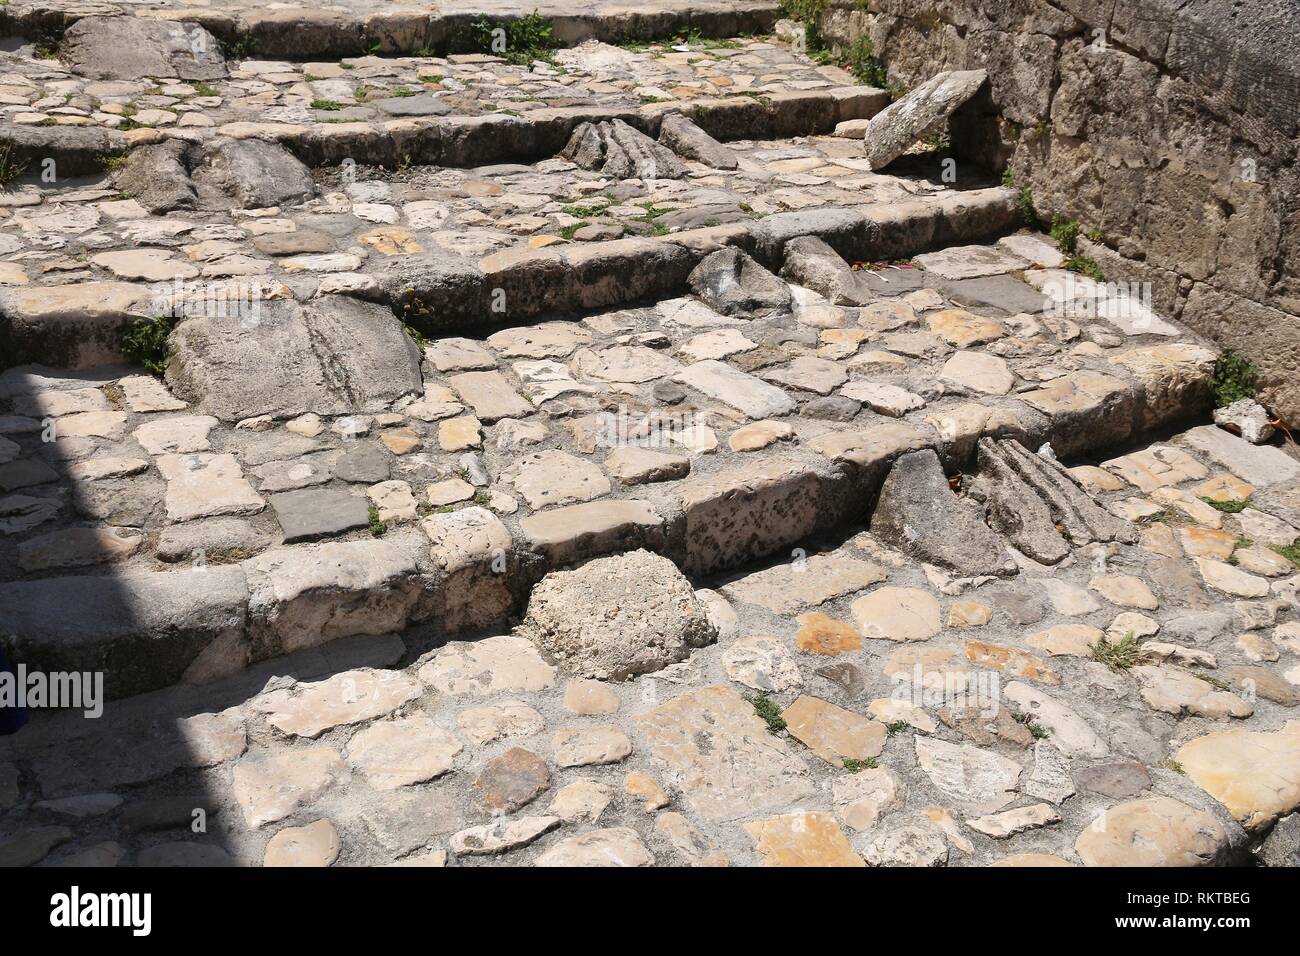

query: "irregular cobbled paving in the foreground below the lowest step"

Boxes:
[0, 425, 1300, 866]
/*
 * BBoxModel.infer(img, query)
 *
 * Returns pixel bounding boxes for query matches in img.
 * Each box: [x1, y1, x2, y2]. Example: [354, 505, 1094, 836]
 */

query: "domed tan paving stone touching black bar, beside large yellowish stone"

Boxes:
[1075, 796, 1227, 866]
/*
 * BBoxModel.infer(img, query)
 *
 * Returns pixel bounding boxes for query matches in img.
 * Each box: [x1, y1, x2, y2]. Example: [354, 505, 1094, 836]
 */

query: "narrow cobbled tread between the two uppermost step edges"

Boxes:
[0, 39, 854, 135]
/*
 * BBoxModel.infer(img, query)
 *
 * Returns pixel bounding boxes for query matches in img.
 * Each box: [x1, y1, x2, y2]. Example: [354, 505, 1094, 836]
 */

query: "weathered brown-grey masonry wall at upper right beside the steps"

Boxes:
[822, 0, 1300, 423]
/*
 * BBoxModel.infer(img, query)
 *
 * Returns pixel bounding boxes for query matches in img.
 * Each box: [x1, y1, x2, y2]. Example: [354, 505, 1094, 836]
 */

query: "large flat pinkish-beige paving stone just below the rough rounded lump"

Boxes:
[636, 687, 813, 822]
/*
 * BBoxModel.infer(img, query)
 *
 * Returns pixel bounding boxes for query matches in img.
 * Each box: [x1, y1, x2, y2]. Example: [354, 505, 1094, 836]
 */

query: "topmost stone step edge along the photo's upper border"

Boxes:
[0, 0, 781, 60]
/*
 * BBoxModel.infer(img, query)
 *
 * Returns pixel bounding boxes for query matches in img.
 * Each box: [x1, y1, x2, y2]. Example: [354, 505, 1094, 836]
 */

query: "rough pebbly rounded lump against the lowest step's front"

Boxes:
[523, 550, 718, 680]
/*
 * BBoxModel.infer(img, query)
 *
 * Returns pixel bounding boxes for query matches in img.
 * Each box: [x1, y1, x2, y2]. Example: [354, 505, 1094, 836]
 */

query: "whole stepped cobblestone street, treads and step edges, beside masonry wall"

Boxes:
[0, 14, 1300, 866]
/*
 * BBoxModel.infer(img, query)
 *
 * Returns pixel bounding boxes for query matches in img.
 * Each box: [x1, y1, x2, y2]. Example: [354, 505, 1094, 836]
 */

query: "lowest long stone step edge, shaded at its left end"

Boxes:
[0, 343, 1216, 698]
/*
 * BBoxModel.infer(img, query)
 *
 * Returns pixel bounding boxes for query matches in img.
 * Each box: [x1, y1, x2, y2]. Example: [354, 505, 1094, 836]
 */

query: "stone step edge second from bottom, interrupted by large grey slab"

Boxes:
[0, 186, 1021, 368]
